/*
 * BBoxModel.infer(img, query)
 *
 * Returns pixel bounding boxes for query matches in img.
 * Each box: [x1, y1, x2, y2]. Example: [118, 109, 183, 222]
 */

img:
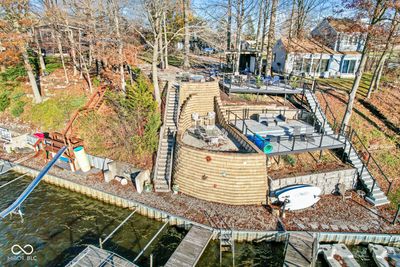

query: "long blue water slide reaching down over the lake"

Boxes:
[0, 146, 67, 220]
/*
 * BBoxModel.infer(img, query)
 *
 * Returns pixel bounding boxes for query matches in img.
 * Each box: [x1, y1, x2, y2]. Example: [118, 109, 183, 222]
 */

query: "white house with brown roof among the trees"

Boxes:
[272, 17, 366, 78]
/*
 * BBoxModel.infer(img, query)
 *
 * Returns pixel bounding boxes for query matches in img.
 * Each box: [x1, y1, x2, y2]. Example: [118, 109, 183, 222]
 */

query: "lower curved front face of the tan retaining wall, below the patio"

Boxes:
[174, 141, 268, 205]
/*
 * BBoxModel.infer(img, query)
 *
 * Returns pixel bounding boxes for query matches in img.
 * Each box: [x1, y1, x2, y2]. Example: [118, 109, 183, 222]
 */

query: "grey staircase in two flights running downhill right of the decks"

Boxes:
[304, 90, 389, 206]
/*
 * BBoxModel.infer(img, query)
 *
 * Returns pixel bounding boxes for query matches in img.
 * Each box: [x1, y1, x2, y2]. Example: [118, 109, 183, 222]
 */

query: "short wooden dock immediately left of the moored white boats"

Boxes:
[283, 232, 314, 267]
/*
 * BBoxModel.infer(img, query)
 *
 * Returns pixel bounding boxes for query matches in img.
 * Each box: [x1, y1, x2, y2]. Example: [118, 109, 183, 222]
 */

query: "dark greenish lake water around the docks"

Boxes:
[0, 172, 283, 267]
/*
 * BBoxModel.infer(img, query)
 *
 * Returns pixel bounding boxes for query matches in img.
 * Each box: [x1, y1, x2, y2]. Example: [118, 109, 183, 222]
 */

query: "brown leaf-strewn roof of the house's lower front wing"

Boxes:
[281, 38, 340, 55]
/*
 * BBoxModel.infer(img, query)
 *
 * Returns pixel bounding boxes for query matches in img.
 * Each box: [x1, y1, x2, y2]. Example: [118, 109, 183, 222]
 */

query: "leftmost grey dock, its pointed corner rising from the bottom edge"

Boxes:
[66, 246, 138, 267]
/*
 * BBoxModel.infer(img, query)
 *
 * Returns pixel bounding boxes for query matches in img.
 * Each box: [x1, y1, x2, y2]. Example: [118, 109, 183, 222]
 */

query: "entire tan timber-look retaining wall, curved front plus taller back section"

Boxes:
[173, 82, 268, 205]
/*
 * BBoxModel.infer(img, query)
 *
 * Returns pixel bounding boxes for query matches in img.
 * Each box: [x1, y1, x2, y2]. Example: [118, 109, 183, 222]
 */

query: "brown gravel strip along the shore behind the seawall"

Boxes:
[0, 152, 400, 234]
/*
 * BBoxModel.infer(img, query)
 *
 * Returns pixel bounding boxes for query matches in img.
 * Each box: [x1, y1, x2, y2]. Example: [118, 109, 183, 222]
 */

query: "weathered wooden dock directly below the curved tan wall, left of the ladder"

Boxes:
[164, 226, 212, 267]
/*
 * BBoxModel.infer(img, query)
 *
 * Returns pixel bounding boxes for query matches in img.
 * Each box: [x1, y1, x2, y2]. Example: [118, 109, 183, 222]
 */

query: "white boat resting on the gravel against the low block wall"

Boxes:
[276, 185, 321, 210]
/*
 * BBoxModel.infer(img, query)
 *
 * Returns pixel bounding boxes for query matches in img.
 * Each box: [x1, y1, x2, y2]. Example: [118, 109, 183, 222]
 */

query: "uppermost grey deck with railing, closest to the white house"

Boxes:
[223, 83, 303, 95]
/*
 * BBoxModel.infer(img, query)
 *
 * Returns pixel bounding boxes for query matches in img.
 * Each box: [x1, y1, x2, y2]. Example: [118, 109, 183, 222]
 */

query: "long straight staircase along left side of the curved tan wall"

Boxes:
[153, 85, 179, 192]
